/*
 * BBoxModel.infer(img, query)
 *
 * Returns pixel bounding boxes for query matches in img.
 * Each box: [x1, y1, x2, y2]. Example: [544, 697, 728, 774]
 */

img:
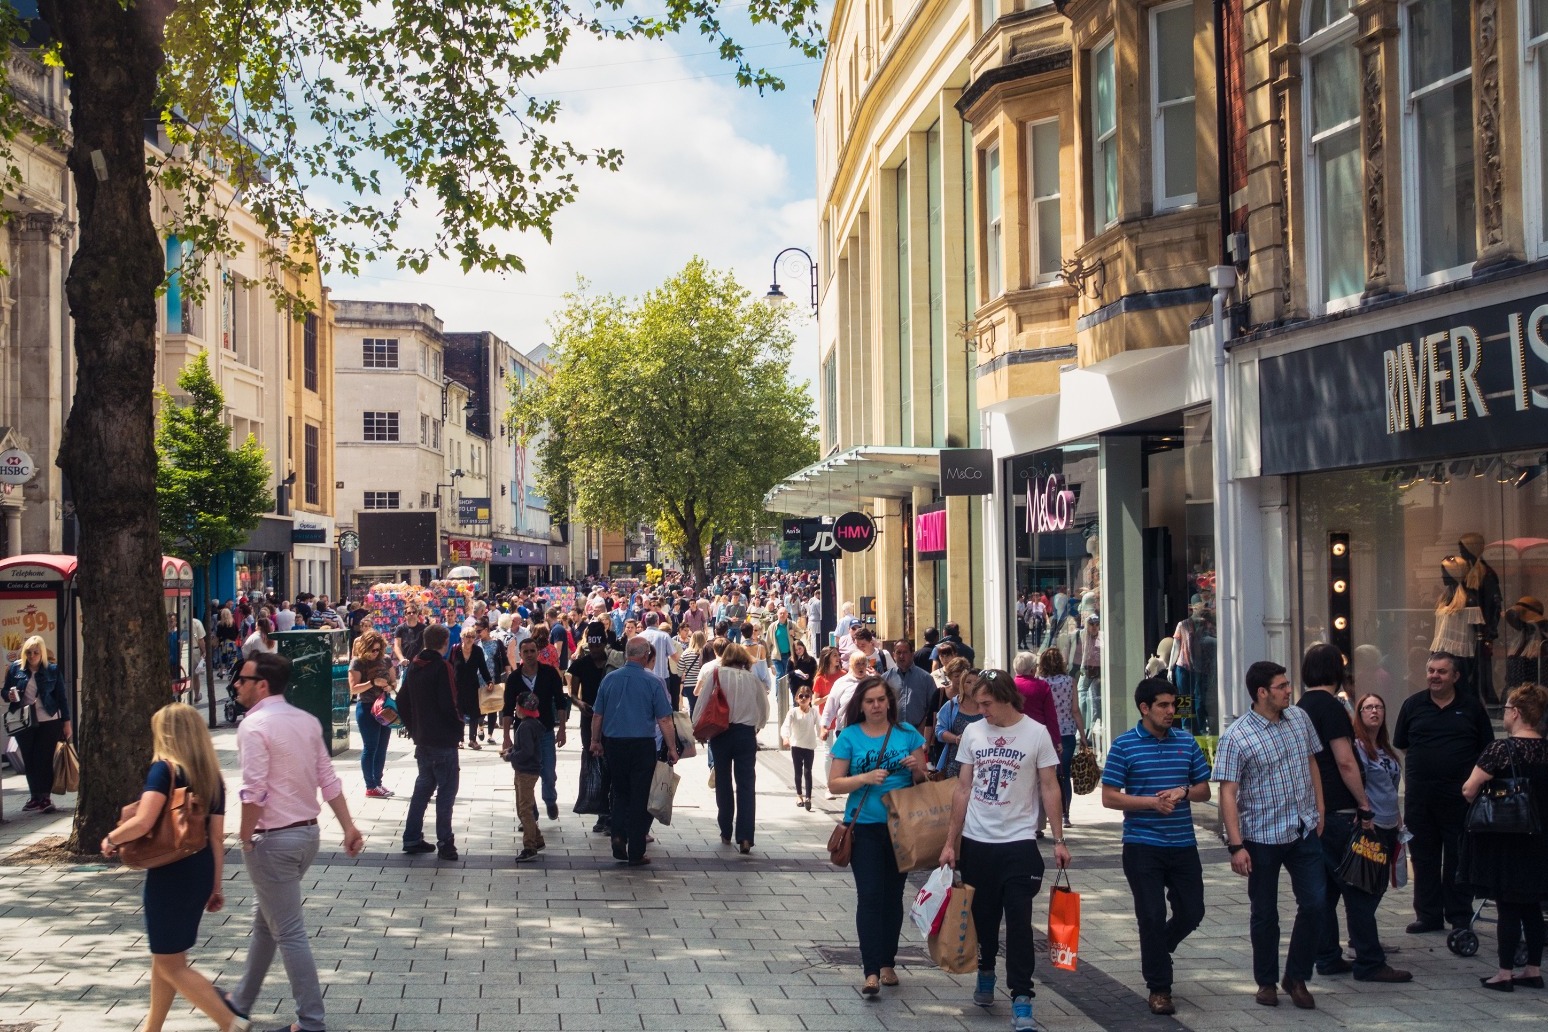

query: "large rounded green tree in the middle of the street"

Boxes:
[509, 258, 817, 583]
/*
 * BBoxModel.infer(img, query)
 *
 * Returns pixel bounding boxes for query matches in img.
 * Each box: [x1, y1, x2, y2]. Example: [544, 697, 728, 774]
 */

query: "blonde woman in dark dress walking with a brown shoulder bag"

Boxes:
[102, 702, 252, 1032]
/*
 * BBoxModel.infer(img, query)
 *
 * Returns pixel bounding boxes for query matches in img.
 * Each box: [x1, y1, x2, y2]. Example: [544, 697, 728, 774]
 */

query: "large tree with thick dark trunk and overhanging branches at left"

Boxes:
[0, 0, 822, 848]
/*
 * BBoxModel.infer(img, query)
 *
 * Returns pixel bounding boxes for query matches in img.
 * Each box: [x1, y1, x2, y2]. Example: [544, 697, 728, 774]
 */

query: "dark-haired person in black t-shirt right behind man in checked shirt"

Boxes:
[1297, 644, 1413, 982]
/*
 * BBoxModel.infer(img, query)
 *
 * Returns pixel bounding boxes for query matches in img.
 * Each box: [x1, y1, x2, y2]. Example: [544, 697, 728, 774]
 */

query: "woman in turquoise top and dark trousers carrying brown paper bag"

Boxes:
[828, 676, 926, 1000]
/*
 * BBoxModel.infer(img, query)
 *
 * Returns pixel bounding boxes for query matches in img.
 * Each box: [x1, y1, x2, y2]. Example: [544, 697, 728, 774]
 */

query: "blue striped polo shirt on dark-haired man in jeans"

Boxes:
[1102, 721, 1209, 848]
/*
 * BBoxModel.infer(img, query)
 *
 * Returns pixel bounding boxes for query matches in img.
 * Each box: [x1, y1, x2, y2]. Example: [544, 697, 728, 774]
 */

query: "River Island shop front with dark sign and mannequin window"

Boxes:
[1255, 275, 1548, 715]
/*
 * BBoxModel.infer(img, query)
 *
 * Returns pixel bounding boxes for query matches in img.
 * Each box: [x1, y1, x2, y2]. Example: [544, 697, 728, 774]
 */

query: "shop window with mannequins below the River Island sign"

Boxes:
[1297, 453, 1548, 712]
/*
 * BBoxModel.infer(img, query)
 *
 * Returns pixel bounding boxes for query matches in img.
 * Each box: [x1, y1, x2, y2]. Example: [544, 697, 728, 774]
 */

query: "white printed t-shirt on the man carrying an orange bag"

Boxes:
[957, 716, 1059, 842]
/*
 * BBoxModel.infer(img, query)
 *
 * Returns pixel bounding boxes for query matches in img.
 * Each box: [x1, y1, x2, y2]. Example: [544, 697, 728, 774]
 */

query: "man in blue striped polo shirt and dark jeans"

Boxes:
[1102, 678, 1209, 1013]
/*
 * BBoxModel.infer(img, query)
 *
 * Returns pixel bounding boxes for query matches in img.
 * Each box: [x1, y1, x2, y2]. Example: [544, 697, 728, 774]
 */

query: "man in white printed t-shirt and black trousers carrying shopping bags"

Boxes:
[941, 670, 1070, 1032]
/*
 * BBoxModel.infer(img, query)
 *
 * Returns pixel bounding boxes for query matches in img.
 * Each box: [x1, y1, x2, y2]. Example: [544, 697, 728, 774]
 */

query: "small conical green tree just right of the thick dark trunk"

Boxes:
[156, 351, 272, 727]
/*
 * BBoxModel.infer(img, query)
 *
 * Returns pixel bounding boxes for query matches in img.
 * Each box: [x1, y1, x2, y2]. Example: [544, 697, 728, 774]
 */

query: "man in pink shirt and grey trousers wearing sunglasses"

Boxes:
[226, 653, 365, 1032]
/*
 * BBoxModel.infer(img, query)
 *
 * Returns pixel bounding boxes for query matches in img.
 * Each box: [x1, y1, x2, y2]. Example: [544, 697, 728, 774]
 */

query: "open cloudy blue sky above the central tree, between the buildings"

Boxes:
[328, 8, 820, 399]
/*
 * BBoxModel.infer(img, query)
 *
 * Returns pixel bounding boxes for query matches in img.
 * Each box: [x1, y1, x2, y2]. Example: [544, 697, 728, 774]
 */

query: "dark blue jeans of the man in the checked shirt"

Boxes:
[1243, 831, 1327, 986]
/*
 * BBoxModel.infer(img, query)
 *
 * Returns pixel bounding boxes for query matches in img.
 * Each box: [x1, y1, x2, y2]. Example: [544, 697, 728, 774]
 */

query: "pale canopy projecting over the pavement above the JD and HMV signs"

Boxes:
[763, 446, 941, 515]
